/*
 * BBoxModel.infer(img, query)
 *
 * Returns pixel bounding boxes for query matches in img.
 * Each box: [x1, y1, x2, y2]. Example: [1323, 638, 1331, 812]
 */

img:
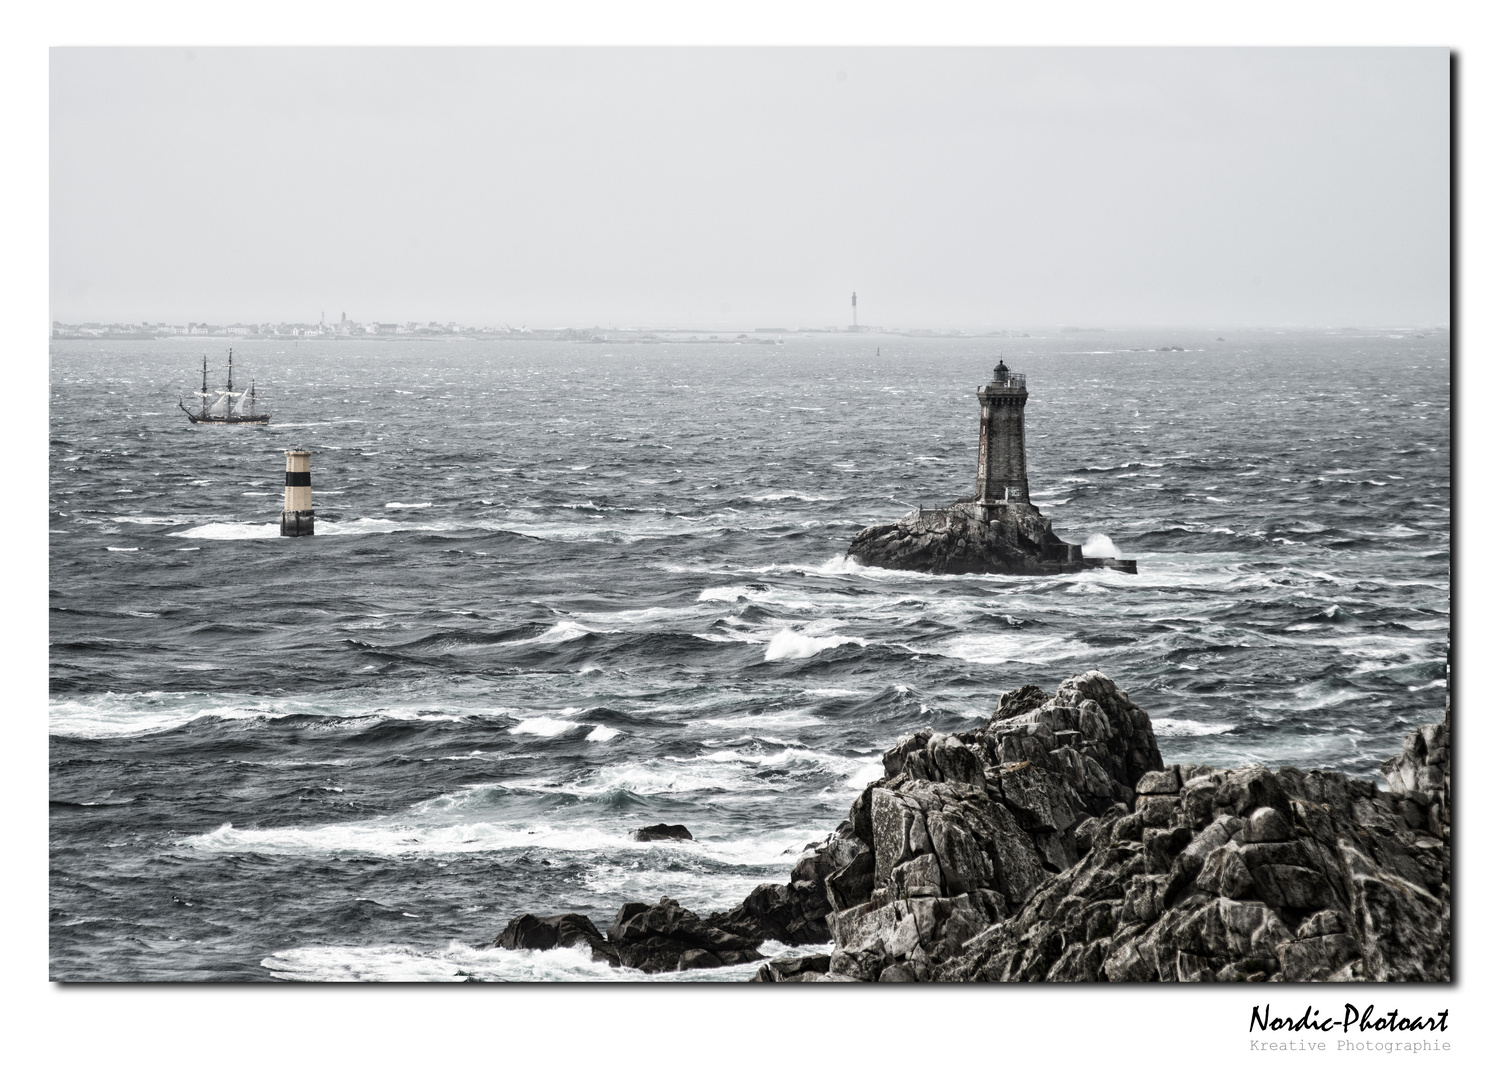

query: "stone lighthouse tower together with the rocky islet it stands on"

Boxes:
[848, 360, 1136, 575]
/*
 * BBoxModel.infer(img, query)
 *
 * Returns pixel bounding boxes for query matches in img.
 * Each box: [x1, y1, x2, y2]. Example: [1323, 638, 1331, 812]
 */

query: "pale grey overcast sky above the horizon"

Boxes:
[51, 48, 1450, 329]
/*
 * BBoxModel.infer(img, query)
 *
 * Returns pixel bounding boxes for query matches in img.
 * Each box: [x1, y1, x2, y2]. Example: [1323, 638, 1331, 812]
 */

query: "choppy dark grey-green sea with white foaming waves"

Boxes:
[49, 330, 1451, 981]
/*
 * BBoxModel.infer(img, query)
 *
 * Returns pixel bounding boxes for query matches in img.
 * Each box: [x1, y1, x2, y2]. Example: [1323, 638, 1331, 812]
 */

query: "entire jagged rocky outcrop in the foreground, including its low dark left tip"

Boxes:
[495, 672, 1451, 983]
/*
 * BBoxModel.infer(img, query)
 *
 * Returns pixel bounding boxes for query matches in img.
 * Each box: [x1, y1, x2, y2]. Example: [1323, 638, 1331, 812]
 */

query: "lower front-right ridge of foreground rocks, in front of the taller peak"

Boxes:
[941, 738, 1451, 983]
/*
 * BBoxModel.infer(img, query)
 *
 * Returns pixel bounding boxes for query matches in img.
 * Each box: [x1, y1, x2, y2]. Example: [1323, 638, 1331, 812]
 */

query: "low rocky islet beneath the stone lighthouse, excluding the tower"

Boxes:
[848, 500, 1138, 575]
